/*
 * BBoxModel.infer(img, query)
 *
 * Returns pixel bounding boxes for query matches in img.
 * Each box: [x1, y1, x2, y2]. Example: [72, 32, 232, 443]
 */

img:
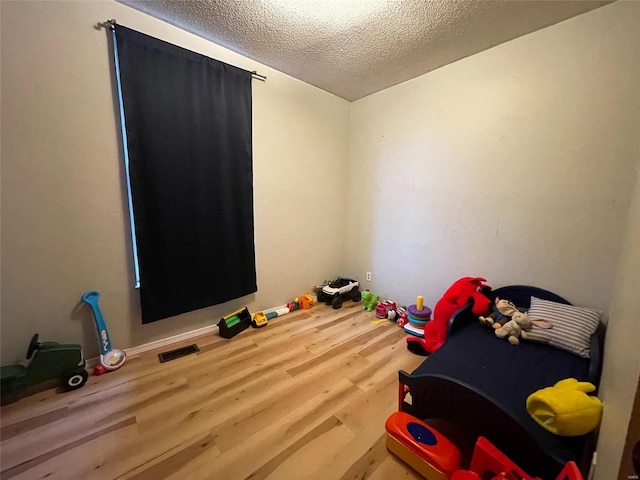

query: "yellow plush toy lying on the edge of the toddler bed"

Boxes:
[527, 378, 603, 437]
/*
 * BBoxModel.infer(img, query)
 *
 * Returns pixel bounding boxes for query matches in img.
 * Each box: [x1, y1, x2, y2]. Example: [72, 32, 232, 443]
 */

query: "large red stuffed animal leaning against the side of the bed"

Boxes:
[407, 277, 491, 355]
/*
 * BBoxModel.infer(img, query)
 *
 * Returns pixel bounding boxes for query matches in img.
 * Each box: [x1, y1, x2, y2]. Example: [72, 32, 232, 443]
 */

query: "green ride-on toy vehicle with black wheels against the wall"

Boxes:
[0, 333, 89, 403]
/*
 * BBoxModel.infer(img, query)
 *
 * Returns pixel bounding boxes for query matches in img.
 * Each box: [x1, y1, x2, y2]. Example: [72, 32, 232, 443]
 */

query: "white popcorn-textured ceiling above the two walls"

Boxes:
[118, 0, 611, 100]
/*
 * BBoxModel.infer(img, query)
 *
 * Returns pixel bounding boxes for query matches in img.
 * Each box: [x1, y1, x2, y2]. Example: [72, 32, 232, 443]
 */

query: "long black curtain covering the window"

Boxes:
[115, 25, 257, 323]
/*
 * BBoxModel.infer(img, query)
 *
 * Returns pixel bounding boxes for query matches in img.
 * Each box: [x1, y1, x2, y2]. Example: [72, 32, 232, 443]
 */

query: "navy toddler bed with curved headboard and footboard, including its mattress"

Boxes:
[399, 285, 603, 478]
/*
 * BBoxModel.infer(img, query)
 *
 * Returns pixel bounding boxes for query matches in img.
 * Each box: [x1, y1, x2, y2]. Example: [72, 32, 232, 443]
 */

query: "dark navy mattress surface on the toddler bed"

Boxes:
[411, 314, 589, 474]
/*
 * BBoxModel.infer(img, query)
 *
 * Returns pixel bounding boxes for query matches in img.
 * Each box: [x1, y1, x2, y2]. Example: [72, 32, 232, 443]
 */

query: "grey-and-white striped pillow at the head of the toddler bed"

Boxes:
[527, 297, 603, 358]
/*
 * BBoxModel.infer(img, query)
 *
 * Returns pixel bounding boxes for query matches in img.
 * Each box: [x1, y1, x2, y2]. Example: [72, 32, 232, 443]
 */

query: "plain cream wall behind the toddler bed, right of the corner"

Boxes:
[346, 2, 640, 310]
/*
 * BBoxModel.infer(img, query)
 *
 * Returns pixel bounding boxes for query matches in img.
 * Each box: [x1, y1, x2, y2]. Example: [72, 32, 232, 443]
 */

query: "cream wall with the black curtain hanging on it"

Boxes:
[0, 1, 349, 364]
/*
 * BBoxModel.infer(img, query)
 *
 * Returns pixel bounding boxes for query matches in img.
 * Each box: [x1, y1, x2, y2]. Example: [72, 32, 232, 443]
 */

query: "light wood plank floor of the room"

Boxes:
[0, 301, 424, 480]
